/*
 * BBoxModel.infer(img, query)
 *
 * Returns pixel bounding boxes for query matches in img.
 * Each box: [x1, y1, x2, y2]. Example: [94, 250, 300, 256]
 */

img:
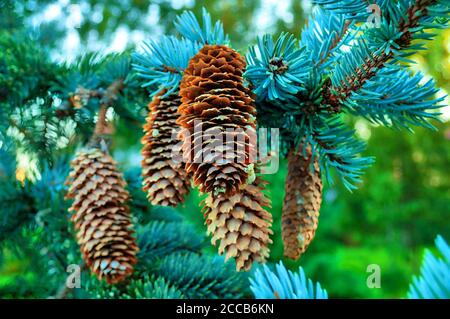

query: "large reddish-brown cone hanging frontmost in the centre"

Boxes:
[177, 45, 256, 196]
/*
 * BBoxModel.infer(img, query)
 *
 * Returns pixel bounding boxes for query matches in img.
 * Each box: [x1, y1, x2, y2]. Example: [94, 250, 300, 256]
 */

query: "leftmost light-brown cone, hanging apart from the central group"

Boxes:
[66, 148, 138, 284]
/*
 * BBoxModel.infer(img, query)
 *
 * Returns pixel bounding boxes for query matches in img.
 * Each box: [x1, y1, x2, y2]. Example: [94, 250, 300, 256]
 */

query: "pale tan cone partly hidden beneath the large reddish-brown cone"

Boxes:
[202, 178, 273, 271]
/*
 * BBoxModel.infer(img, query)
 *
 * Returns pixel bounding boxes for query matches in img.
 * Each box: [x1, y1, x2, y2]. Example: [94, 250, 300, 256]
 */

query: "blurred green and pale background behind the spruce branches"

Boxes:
[0, 0, 450, 298]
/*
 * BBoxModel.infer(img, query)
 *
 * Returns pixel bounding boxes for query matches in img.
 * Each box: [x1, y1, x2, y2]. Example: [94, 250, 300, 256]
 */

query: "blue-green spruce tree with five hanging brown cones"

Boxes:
[0, 0, 450, 298]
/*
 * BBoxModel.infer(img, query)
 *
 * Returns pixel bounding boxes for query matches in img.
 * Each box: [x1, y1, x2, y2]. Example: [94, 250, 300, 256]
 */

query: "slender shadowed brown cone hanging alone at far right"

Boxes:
[282, 147, 322, 260]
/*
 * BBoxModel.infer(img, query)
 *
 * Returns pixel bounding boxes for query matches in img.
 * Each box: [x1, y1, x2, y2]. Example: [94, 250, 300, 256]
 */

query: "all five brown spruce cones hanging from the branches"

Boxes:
[68, 45, 322, 283]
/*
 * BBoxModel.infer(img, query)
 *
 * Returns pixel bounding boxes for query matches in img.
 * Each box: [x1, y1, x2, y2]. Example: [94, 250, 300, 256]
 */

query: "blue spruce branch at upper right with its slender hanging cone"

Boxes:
[244, 0, 449, 258]
